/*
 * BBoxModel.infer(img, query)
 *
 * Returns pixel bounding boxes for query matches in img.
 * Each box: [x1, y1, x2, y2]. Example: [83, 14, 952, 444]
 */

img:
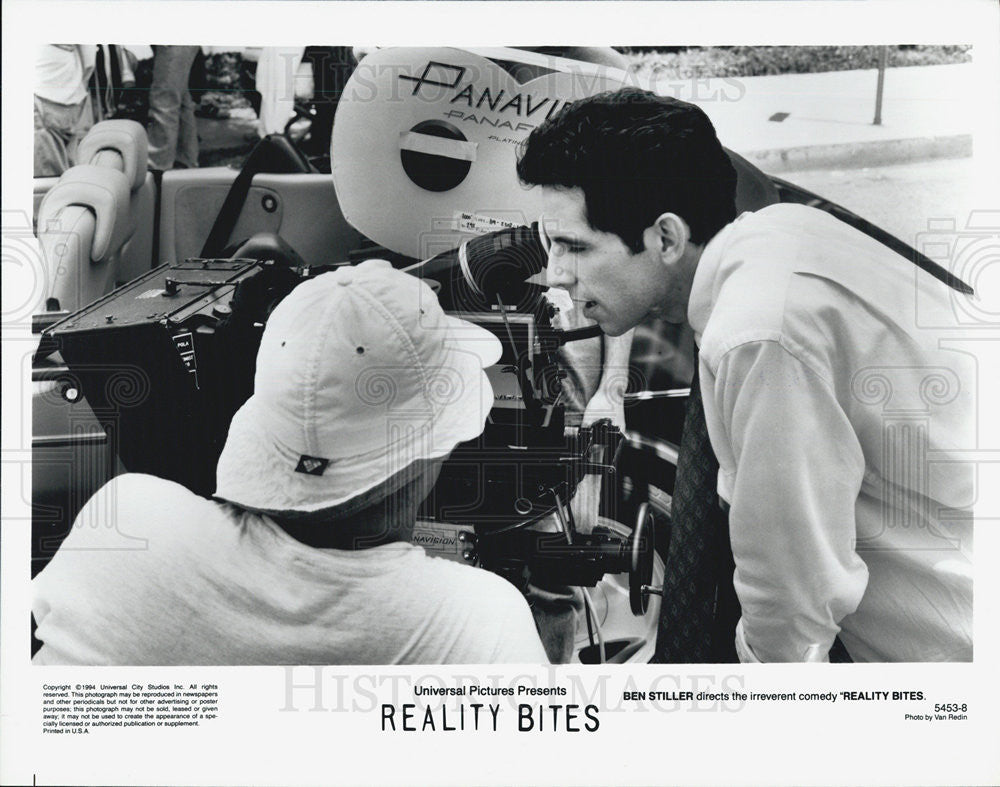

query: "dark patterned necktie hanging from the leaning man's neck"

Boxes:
[653, 356, 739, 664]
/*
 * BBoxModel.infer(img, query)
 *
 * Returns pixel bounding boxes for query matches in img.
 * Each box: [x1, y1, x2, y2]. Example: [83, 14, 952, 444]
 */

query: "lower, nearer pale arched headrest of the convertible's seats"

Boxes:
[38, 164, 130, 262]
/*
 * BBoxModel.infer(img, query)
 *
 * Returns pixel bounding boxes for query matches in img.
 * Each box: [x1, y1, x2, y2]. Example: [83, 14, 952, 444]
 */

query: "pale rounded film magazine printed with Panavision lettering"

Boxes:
[332, 47, 626, 259]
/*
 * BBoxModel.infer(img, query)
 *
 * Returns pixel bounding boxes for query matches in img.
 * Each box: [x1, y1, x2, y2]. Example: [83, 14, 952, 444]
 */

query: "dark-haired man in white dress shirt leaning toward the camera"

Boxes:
[518, 89, 975, 661]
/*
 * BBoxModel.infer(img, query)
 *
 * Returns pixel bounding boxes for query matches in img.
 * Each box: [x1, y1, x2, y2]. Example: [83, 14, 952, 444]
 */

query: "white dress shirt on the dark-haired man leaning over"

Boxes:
[688, 205, 976, 661]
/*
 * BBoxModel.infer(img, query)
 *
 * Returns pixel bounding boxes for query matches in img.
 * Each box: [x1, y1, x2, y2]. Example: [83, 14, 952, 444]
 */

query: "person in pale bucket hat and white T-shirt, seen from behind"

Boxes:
[33, 261, 546, 665]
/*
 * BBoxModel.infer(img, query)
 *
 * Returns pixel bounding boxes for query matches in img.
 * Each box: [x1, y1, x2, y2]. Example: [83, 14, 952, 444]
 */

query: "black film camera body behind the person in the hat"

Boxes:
[44, 227, 655, 614]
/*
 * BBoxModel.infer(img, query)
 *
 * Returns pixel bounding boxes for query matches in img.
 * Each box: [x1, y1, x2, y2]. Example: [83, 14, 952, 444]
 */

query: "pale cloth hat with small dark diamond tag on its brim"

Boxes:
[215, 260, 501, 513]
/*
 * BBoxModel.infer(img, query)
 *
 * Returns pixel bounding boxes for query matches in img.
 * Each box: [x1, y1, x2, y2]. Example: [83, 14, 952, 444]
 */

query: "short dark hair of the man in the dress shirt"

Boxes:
[517, 88, 736, 253]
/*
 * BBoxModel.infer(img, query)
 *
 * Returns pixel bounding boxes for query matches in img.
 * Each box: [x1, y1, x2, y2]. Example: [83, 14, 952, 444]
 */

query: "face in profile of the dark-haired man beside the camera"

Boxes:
[540, 186, 687, 336]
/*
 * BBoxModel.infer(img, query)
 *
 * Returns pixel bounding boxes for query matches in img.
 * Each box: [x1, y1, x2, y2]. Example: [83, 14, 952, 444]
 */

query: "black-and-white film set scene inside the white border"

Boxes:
[21, 45, 976, 665]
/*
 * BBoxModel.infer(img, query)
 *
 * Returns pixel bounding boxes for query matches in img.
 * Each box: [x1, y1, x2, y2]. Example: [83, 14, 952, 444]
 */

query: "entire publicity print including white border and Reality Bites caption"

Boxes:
[2, 2, 1000, 784]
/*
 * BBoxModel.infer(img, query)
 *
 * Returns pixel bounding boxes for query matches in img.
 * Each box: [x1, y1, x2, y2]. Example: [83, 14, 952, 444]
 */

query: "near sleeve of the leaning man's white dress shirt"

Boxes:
[702, 341, 868, 662]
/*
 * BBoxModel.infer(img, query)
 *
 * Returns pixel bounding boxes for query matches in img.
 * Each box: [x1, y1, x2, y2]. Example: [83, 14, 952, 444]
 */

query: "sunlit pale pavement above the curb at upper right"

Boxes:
[198, 63, 975, 173]
